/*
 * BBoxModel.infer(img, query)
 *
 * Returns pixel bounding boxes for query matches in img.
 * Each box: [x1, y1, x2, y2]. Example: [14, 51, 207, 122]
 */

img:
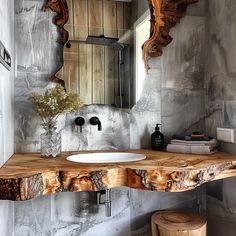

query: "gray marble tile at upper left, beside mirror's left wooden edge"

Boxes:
[15, 0, 62, 74]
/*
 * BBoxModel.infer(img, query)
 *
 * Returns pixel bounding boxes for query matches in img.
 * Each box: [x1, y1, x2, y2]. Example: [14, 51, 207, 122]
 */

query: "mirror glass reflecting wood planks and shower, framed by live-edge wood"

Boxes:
[56, 0, 150, 109]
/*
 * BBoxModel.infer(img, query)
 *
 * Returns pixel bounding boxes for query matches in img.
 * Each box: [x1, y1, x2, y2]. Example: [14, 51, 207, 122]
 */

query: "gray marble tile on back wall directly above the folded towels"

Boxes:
[162, 89, 205, 141]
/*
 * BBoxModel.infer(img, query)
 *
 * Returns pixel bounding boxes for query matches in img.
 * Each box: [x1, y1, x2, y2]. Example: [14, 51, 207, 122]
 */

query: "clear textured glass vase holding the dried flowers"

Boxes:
[40, 129, 61, 157]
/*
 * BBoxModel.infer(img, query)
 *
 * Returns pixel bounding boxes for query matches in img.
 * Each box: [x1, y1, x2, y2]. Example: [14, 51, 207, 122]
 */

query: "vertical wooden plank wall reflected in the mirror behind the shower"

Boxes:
[56, 0, 132, 106]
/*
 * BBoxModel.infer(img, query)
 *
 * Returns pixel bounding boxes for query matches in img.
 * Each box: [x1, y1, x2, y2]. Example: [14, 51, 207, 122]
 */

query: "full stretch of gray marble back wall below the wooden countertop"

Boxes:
[15, 186, 206, 236]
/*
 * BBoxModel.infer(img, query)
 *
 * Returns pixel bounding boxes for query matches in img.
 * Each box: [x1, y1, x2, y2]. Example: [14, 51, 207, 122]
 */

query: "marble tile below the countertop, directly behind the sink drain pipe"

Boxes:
[51, 188, 130, 236]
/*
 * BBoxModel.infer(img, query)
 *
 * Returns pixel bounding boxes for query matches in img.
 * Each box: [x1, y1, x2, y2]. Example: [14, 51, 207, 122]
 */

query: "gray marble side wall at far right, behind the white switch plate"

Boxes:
[205, 0, 236, 236]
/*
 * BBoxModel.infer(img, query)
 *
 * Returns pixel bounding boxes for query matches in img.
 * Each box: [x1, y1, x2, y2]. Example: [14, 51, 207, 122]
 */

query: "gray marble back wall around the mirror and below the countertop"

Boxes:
[14, 0, 205, 236]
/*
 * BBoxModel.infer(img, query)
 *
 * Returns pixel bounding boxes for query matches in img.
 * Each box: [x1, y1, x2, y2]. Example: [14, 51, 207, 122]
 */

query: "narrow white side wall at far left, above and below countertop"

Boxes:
[0, 0, 15, 236]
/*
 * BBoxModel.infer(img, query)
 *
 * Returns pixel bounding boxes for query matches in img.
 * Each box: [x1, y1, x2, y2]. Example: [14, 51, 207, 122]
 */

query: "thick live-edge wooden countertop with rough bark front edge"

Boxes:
[0, 149, 236, 201]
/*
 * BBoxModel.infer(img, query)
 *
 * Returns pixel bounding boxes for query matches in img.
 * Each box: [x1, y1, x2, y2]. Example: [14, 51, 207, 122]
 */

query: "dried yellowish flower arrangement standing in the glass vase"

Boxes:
[30, 85, 83, 133]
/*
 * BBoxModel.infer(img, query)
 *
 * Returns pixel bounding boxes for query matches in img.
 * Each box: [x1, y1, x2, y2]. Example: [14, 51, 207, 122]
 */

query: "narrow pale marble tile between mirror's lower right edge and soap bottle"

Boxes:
[130, 58, 161, 149]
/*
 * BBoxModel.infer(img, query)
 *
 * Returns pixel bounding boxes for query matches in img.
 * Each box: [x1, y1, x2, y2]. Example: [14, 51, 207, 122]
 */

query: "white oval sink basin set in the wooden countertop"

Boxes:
[66, 152, 146, 163]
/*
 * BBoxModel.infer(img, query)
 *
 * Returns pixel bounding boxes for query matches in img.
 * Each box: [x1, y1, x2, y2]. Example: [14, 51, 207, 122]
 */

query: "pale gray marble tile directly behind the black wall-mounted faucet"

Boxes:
[62, 105, 130, 151]
